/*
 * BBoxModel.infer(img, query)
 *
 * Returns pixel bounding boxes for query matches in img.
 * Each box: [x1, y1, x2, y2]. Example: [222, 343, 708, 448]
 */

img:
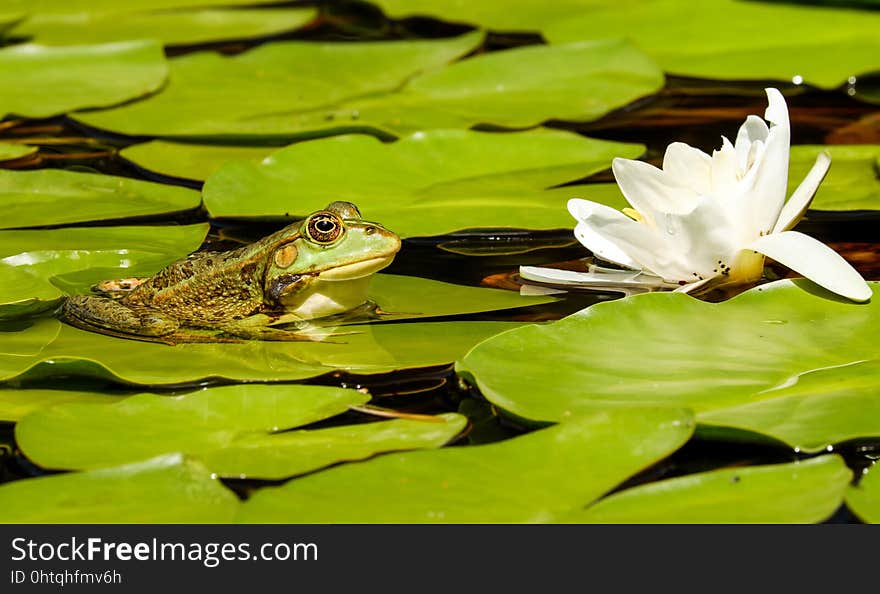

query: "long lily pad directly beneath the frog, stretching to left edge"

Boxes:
[0, 319, 518, 385]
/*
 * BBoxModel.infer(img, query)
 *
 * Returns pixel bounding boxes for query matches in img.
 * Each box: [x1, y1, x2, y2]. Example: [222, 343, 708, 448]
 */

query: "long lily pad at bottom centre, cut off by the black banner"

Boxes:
[238, 408, 693, 524]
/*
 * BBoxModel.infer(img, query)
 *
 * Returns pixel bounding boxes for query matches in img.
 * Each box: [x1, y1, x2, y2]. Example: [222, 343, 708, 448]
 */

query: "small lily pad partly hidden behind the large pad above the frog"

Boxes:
[119, 140, 278, 181]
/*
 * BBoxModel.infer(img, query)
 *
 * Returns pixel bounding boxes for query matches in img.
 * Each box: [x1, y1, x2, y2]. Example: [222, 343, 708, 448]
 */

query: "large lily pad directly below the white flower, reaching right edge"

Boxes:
[458, 281, 880, 447]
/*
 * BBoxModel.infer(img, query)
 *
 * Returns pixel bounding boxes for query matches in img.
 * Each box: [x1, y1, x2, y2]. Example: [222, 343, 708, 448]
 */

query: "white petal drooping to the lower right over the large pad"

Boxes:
[748, 231, 871, 301]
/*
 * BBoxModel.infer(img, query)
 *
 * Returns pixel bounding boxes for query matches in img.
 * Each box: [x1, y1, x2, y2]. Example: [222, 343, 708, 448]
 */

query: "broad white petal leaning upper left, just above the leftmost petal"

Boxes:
[611, 157, 697, 214]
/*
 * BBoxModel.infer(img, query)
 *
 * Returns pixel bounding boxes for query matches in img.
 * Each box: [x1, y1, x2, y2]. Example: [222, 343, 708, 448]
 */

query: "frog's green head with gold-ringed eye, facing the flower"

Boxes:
[265, 202, 400, 304]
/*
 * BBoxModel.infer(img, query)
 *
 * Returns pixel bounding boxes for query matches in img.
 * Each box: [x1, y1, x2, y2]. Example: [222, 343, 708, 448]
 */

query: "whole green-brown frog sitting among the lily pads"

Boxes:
[61, 201, 401, 345]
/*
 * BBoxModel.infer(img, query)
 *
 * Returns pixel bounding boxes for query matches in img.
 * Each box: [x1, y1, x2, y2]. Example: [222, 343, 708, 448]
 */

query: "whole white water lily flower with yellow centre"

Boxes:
[521, 89, 871, 301]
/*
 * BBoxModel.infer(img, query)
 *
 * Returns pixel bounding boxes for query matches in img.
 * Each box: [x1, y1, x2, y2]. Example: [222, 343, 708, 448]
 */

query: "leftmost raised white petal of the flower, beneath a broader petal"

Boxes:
[568, 198, 666, 269]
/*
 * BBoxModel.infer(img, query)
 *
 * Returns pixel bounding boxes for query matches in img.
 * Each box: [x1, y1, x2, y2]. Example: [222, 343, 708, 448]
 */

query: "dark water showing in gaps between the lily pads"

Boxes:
[0, 2, 880, 522]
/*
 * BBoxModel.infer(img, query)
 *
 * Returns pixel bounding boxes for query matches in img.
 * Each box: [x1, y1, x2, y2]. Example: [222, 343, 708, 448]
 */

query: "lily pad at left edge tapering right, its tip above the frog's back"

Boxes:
[0, 169, 201, 229]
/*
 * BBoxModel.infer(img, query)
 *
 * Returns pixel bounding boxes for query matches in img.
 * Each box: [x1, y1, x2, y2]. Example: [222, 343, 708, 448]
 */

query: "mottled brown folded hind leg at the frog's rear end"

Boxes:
[61, 295, 180, 337]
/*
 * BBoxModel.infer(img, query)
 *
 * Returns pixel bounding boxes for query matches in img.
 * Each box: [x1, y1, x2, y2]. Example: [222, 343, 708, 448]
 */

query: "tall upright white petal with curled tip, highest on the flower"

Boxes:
[740, 89, 791, 232]
